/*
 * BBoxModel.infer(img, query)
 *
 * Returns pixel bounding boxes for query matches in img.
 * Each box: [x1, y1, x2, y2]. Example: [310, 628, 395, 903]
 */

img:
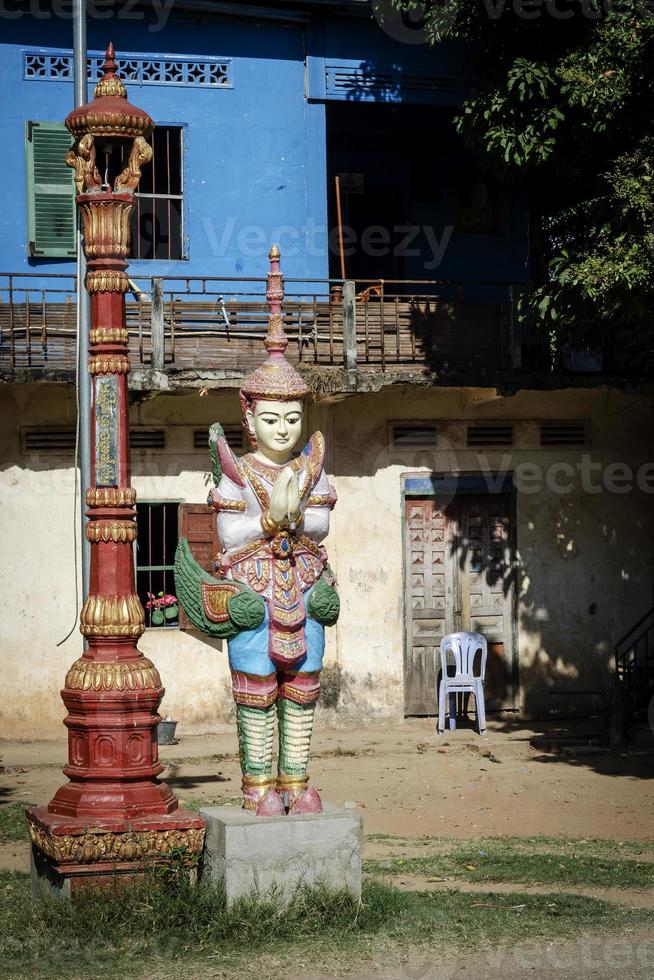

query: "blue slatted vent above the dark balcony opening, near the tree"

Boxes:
[325, 65, 459, 103]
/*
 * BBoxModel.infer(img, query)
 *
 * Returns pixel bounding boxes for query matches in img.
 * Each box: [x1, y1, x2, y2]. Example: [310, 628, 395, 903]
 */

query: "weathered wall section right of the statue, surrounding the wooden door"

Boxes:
[330, 389, 654, 715]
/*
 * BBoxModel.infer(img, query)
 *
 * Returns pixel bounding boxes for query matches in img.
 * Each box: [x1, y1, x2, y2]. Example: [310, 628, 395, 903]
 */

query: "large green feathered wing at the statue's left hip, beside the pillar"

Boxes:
[175, 538, 266, 640]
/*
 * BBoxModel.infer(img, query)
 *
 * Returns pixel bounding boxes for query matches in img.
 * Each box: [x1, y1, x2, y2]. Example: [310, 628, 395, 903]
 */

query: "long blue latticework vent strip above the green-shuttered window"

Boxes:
[23, 51, 232, 88]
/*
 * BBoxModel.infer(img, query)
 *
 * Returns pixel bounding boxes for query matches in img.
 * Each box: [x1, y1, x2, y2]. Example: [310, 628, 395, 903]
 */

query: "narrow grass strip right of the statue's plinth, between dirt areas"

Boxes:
[366, 836, 654, 888]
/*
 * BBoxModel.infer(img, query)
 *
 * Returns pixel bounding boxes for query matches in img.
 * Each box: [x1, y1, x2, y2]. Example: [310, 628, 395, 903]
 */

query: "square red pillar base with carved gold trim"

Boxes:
[26, 807, 204, 897]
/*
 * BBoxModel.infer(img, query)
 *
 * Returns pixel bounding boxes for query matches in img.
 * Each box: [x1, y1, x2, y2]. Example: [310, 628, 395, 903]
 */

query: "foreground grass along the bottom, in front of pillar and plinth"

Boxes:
[0, 872, 654, 980]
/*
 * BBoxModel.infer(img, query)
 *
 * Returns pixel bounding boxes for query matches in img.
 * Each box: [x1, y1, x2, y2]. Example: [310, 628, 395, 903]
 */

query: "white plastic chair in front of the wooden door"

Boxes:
[438, 633, 488, 735]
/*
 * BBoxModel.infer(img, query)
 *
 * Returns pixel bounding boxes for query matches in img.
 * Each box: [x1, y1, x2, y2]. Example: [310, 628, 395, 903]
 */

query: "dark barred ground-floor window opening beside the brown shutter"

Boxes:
[136, 500, 179, 629]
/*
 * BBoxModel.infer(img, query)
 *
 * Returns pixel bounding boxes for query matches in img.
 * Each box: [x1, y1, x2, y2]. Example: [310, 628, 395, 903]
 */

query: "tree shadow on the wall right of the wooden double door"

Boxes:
[446, 494, 650, 719]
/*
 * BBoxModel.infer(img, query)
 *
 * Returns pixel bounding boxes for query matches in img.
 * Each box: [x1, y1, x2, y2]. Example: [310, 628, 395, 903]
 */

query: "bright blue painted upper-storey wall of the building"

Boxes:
[0, 8, 527, 290]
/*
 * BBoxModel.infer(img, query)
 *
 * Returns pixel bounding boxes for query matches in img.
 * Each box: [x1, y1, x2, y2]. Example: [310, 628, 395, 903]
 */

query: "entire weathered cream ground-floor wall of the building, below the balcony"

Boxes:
[0, 385, 654, 738]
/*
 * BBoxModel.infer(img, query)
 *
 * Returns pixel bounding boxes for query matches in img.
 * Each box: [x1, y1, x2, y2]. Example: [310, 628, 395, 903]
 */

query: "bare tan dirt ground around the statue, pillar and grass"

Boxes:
[0, 719, 654, 980]
